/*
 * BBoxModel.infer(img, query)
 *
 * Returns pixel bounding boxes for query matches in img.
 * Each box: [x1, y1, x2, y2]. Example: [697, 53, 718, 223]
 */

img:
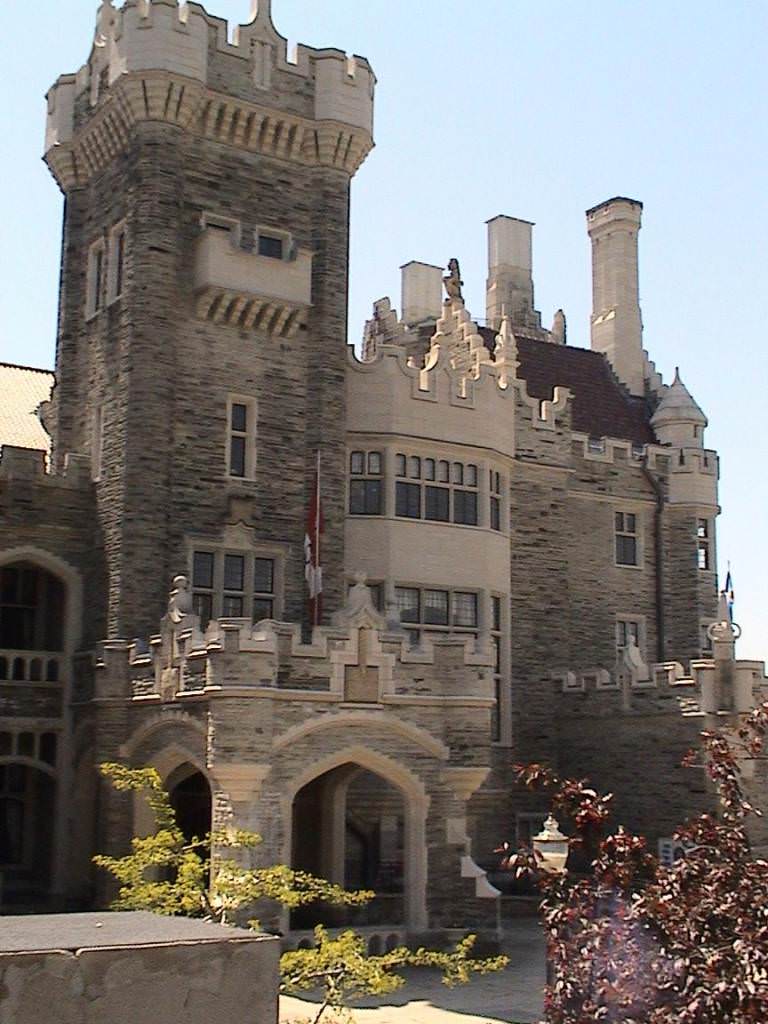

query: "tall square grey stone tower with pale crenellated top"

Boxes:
[45, 0, 375, 638]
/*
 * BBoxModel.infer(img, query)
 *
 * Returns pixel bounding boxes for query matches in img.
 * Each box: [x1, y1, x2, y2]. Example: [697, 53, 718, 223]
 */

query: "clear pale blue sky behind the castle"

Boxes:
[0, 0, 768, 657]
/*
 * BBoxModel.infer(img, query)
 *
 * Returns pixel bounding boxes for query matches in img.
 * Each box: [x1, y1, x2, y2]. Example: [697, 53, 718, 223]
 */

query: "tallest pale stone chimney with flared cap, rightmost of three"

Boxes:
[587, 197, 645, 395]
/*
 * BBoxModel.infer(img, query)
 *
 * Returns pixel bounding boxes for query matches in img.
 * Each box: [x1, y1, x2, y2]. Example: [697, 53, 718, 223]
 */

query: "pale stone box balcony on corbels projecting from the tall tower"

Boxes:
[195, 225, 312, 338]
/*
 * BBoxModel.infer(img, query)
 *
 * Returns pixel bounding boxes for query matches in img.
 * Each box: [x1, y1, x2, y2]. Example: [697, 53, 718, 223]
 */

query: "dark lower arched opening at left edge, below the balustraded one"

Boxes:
[0, 762, 56, 910]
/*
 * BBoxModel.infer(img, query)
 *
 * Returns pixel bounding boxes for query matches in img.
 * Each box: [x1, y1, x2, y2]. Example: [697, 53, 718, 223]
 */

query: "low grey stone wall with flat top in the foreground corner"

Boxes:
[0, 913, 280, 1024]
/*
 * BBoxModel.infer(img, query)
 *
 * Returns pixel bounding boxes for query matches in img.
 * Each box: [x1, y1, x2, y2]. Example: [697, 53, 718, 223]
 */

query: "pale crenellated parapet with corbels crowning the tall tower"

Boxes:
[45, 0, 376, 191]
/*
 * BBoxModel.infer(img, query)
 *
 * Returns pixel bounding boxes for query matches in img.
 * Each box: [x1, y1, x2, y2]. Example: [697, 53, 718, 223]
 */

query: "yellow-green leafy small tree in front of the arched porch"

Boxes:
[93, 764, 507, 1024]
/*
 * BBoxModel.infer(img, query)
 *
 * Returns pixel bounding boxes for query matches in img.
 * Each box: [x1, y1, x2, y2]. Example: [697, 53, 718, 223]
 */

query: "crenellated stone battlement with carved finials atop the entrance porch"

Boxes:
[97, 578, 494, 708]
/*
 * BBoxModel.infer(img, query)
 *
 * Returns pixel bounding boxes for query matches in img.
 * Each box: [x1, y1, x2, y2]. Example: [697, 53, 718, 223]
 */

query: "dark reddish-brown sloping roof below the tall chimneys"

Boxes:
[480, 328, 655, 444]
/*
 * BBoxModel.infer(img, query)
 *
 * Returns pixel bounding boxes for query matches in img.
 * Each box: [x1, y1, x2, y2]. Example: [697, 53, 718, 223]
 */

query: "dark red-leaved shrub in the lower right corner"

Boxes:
[505, 703, 768, 1024]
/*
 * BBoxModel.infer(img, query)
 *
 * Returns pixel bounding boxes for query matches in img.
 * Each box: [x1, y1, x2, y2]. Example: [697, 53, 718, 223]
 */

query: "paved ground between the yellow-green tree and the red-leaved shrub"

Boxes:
[280, 921, 544, 1024]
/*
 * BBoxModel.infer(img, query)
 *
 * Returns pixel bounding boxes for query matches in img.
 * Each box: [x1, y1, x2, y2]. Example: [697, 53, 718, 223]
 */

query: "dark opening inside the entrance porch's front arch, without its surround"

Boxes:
[291, 763, 407, 928]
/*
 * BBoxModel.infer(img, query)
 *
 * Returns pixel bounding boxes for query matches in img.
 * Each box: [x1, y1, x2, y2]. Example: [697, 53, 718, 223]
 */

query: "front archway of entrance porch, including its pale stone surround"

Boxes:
[284, 746, 428, 931]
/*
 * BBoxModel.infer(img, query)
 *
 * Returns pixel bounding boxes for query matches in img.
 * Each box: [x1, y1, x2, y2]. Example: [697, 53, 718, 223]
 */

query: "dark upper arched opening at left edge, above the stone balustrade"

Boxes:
[0, 561, 65, 650]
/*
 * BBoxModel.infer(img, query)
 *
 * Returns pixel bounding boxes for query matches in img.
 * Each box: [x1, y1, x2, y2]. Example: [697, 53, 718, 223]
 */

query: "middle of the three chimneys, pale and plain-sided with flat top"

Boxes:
[485, 215, 541, 331]
